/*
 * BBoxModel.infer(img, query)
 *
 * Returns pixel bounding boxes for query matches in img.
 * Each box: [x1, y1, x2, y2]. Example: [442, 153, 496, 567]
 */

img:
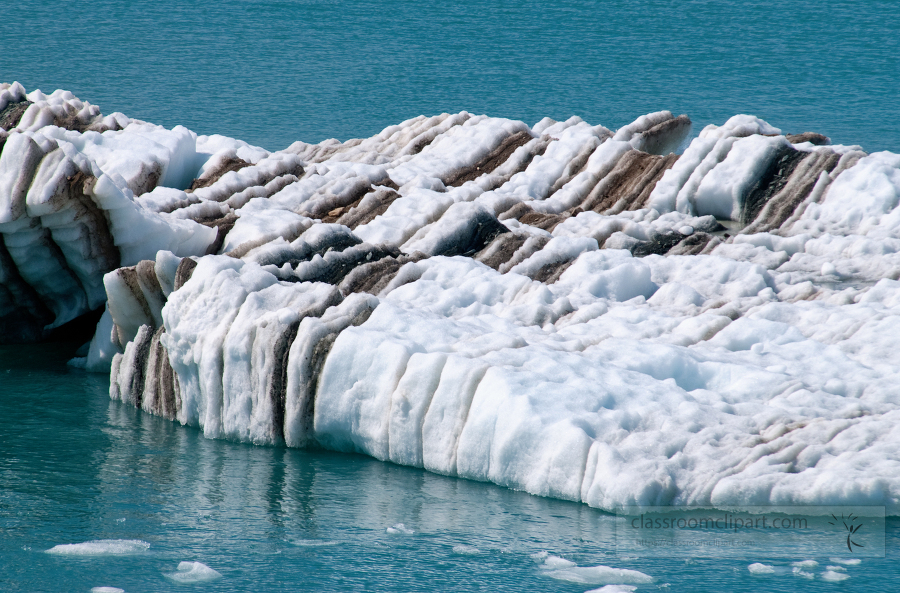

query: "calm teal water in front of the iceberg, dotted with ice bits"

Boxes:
[0, 344, 900, 593]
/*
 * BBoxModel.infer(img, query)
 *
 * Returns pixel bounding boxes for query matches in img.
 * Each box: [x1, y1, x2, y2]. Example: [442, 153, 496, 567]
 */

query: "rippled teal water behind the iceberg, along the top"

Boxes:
[0, 0, 900, 151]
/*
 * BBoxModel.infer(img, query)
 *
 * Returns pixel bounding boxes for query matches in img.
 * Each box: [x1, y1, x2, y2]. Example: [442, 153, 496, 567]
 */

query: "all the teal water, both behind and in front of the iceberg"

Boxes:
[0, 0, 900, 593]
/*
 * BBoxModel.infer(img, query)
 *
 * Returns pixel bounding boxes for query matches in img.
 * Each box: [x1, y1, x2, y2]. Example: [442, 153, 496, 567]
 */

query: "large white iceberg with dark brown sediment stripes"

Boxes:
[0, 84, 900, 512]
